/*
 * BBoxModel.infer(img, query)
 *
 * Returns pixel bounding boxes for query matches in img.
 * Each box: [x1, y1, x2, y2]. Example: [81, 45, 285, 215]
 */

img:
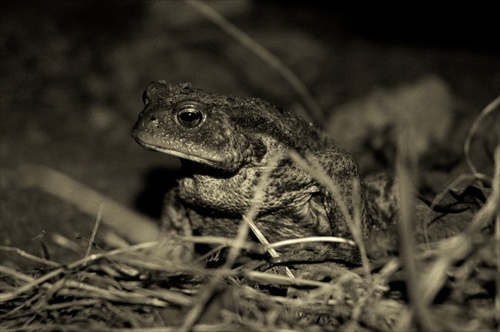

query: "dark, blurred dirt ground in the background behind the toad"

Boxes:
[0, 1, 500, 330]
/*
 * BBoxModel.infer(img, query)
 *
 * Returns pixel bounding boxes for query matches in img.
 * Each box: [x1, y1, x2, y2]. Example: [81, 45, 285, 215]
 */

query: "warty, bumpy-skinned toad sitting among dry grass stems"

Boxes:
[132, 81, 394, 259]
